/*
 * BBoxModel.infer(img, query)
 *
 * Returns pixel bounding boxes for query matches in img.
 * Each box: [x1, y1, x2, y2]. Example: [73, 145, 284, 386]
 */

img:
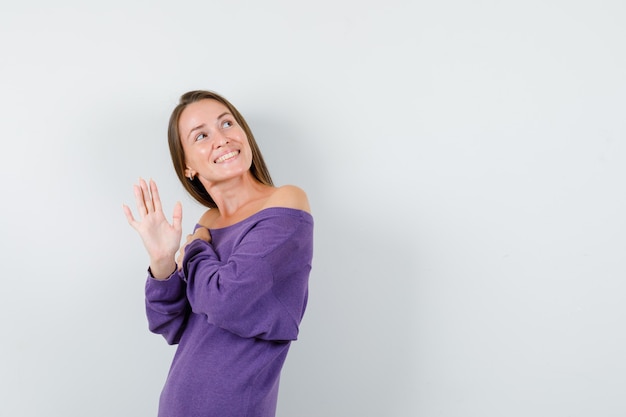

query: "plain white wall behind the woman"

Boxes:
[0, 0, 626, 417]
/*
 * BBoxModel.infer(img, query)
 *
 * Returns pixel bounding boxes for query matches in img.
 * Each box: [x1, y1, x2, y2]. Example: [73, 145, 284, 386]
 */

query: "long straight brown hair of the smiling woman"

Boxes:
[167, 90, 274, 208]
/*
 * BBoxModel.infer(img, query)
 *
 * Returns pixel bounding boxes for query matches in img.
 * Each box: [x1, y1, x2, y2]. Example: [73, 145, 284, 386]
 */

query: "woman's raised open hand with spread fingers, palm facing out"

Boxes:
[123, 179, 183, 279]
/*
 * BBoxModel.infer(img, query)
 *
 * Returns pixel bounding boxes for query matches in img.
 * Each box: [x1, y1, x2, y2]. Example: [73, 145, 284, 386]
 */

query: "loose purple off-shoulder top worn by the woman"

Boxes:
[146, 207, 313, 417]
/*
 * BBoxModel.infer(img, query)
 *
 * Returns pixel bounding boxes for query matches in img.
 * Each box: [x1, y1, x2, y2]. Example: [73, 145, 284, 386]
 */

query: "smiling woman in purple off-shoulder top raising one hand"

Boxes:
[124, 91, 313, 417]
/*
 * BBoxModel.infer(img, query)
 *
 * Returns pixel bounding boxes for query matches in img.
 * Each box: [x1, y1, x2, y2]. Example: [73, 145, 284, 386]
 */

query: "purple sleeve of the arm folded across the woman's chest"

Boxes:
[182, 211, 312, 341]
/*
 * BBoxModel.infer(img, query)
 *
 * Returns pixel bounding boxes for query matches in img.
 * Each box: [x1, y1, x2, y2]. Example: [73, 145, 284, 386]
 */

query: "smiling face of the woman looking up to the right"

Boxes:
[178, 99, 252, 186]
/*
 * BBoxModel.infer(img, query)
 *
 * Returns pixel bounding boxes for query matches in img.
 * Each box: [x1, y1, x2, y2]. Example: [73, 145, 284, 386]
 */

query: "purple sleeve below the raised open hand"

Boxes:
[146, 270, 191, 345]
